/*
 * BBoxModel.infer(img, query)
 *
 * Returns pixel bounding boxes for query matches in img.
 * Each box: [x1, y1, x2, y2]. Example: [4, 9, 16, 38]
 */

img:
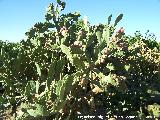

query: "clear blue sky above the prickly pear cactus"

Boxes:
[0, 0, 160, 42]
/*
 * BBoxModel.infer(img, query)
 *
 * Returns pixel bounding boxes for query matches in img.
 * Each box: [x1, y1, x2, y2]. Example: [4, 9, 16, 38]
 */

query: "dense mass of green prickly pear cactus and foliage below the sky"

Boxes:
[0, 0, 160, 119]
